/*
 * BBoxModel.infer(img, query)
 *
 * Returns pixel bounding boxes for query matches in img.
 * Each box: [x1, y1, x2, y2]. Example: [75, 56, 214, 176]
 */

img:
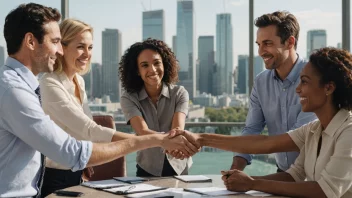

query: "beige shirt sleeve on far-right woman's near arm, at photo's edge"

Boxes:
[318, 127, 352, 198]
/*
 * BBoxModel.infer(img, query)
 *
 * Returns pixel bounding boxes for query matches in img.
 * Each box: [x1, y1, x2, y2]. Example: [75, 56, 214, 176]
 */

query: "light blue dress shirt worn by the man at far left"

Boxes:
[0, 57, 92, 197]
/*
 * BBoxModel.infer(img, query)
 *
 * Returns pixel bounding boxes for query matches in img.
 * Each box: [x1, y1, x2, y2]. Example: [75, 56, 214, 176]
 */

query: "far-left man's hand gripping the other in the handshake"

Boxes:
[162, 135, 198, 158]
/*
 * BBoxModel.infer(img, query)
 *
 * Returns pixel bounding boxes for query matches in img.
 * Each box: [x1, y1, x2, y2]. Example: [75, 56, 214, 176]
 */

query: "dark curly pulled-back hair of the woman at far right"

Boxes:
[309, 47, 352, 111]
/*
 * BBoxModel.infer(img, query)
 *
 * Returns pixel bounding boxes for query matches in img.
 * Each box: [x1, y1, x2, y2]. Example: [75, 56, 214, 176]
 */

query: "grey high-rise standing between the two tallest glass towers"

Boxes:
[196, 36, 215, 94]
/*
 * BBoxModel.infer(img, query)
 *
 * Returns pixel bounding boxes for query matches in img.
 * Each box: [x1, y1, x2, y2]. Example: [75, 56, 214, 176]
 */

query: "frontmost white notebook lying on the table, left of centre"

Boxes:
[103, 184, 167, 195]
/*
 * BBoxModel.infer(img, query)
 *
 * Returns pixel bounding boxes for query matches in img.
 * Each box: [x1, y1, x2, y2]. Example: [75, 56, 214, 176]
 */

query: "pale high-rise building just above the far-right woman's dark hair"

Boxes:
[306, 30, 326, 59]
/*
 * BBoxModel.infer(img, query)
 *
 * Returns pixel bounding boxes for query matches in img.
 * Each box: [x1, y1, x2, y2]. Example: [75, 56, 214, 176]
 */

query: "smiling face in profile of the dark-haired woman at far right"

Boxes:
[296, 62, 332, 112]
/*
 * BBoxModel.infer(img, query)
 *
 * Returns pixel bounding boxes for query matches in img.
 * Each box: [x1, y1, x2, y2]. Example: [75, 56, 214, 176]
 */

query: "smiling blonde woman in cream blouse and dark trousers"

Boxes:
[40, 19, 198, 196]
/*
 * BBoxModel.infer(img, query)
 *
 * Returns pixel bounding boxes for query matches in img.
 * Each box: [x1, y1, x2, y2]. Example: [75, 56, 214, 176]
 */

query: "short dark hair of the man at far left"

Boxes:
[4, 3, 61, 55]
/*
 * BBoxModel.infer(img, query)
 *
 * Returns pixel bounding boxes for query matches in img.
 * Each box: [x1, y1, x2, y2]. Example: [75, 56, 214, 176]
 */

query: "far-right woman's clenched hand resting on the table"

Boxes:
[221, 169, 254, 192]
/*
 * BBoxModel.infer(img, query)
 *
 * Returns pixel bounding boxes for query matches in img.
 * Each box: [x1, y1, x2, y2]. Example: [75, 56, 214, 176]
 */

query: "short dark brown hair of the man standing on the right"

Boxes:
[254, 11, 300, 49]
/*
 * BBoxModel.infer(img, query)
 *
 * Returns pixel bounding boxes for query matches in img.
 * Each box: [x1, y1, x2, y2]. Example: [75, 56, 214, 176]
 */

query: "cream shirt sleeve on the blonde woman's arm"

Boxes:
[40, 79, 115, 142]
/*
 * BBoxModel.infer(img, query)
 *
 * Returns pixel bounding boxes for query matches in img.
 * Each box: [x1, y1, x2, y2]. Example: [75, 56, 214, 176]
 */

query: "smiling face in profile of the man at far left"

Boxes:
[32, 21, 63, 74]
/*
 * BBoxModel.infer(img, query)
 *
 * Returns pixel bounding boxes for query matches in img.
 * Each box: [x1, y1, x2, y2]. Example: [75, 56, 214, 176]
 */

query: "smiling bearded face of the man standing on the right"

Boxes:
[256, 25, 289, 69]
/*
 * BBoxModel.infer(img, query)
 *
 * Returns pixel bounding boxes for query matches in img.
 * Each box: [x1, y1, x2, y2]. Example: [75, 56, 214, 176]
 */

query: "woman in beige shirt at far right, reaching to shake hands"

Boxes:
[172, 48, 352, 198]
